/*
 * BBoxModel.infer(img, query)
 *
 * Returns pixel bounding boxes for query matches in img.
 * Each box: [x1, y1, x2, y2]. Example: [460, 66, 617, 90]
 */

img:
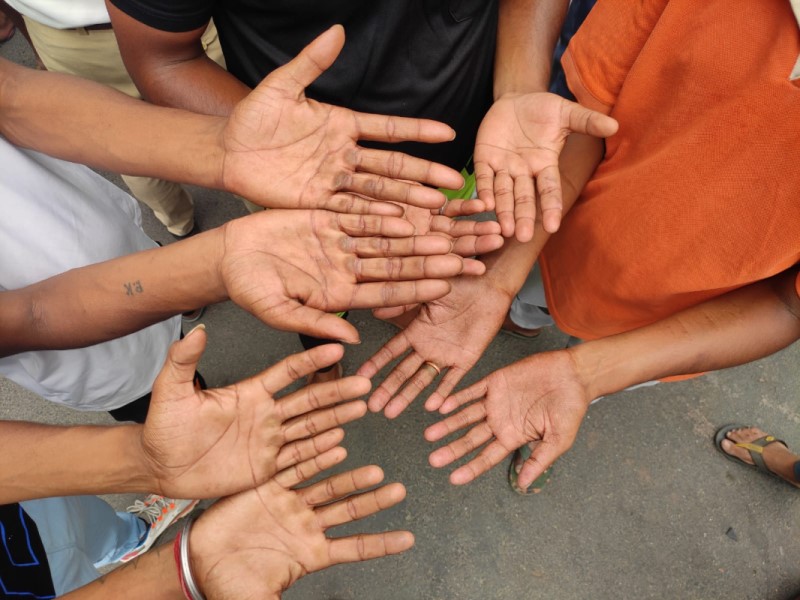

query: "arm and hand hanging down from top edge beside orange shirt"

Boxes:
[474, 0, 617, 242]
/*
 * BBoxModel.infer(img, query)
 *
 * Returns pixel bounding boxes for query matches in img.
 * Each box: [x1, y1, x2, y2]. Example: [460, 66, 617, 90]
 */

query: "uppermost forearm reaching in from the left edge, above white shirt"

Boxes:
[0, 59, 226, 188]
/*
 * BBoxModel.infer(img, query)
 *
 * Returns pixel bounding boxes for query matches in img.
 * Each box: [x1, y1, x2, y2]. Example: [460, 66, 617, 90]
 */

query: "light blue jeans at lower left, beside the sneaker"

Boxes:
[20, 496, 147, 596]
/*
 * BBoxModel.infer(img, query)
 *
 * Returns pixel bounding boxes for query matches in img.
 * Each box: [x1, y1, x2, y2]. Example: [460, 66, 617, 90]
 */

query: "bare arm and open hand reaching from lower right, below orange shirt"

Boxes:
[425, 267, 800, 488]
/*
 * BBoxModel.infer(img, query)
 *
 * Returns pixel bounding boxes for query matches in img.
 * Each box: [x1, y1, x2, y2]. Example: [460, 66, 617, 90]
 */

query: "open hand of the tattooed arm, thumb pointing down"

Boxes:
[219, 210, 484, 343]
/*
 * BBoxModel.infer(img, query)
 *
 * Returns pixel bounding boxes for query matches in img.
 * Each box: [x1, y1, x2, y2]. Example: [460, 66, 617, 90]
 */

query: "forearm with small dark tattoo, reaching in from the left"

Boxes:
[0, 228, 227, 356]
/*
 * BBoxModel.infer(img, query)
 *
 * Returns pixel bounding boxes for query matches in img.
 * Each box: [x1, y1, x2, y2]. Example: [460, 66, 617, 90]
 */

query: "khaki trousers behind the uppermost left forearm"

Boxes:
[25, 17, 225, 235]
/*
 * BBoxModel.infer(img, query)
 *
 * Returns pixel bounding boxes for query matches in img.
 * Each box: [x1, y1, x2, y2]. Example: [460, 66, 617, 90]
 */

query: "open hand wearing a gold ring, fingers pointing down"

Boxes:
[358, 277, 512, 419]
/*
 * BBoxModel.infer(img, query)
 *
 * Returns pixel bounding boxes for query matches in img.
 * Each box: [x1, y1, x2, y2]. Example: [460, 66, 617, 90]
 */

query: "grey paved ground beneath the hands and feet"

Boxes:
[0, 36, 800, 600]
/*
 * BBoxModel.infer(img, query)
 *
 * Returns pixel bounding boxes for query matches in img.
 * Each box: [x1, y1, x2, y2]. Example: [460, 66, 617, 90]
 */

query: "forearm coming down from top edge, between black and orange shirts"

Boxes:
[494, 0, 569, 99]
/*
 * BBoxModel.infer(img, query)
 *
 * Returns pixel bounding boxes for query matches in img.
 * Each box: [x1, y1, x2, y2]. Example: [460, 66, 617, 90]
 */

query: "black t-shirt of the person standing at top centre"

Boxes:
[112, 0, 498, 169]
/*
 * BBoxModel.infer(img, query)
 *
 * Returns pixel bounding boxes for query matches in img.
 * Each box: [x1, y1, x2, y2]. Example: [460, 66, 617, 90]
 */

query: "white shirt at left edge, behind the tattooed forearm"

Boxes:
[0, 137, 180, 410]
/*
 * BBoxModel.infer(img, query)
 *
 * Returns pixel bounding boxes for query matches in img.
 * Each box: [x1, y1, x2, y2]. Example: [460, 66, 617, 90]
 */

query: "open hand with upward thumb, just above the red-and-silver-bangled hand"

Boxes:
[141, 328, 370, 498]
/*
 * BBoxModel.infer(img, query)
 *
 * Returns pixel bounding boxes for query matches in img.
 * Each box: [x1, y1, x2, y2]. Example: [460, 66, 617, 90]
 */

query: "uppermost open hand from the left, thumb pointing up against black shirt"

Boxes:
[222, 25, 463, 215]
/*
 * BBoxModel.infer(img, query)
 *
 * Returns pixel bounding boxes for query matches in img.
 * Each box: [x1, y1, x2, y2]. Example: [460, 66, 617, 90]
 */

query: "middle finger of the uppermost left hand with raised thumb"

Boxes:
[356, 148, 464, 196]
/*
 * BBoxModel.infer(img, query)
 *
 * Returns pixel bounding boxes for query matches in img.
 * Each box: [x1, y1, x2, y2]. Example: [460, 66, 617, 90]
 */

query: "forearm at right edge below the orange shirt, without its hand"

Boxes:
[569, 269, 800, 399]
